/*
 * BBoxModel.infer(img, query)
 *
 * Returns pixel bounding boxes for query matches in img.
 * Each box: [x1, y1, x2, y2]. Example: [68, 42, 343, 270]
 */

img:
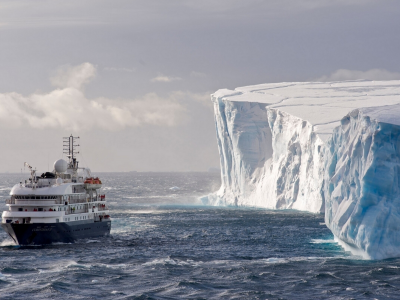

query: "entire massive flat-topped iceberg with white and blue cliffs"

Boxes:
[203, 81, 400, 258]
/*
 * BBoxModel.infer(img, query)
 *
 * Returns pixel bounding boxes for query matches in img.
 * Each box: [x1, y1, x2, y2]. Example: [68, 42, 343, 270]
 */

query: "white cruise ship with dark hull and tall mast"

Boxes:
[1, 135, 111, 245]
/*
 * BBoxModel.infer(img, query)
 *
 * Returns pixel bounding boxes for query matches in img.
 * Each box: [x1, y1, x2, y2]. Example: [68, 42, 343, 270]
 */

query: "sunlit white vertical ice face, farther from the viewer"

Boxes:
[203, 97, 323, 212]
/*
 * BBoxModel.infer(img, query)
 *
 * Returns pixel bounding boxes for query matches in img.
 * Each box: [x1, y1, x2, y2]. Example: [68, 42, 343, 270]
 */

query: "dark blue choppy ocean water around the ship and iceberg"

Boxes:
[0, 173, 400, 299]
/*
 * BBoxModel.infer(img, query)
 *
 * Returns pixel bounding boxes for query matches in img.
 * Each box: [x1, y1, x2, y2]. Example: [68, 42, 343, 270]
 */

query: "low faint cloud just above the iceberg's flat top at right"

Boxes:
[314, 69, 400, 81]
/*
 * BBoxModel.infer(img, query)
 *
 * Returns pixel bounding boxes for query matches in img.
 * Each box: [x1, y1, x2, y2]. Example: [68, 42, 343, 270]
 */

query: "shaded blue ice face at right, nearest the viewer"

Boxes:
[324, 105, 400, 259]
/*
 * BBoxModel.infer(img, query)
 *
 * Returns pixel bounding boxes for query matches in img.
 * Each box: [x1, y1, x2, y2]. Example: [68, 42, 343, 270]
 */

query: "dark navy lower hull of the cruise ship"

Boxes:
[1, 220, 111, 245]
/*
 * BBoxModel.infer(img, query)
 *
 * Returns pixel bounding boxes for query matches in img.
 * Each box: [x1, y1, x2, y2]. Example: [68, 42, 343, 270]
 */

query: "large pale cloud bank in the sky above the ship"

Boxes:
[0, 63, 187, 131]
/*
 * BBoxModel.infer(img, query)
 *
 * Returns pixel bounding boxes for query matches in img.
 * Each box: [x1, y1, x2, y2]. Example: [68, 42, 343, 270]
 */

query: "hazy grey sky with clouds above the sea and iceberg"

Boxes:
[0, 0, 400, 172]
